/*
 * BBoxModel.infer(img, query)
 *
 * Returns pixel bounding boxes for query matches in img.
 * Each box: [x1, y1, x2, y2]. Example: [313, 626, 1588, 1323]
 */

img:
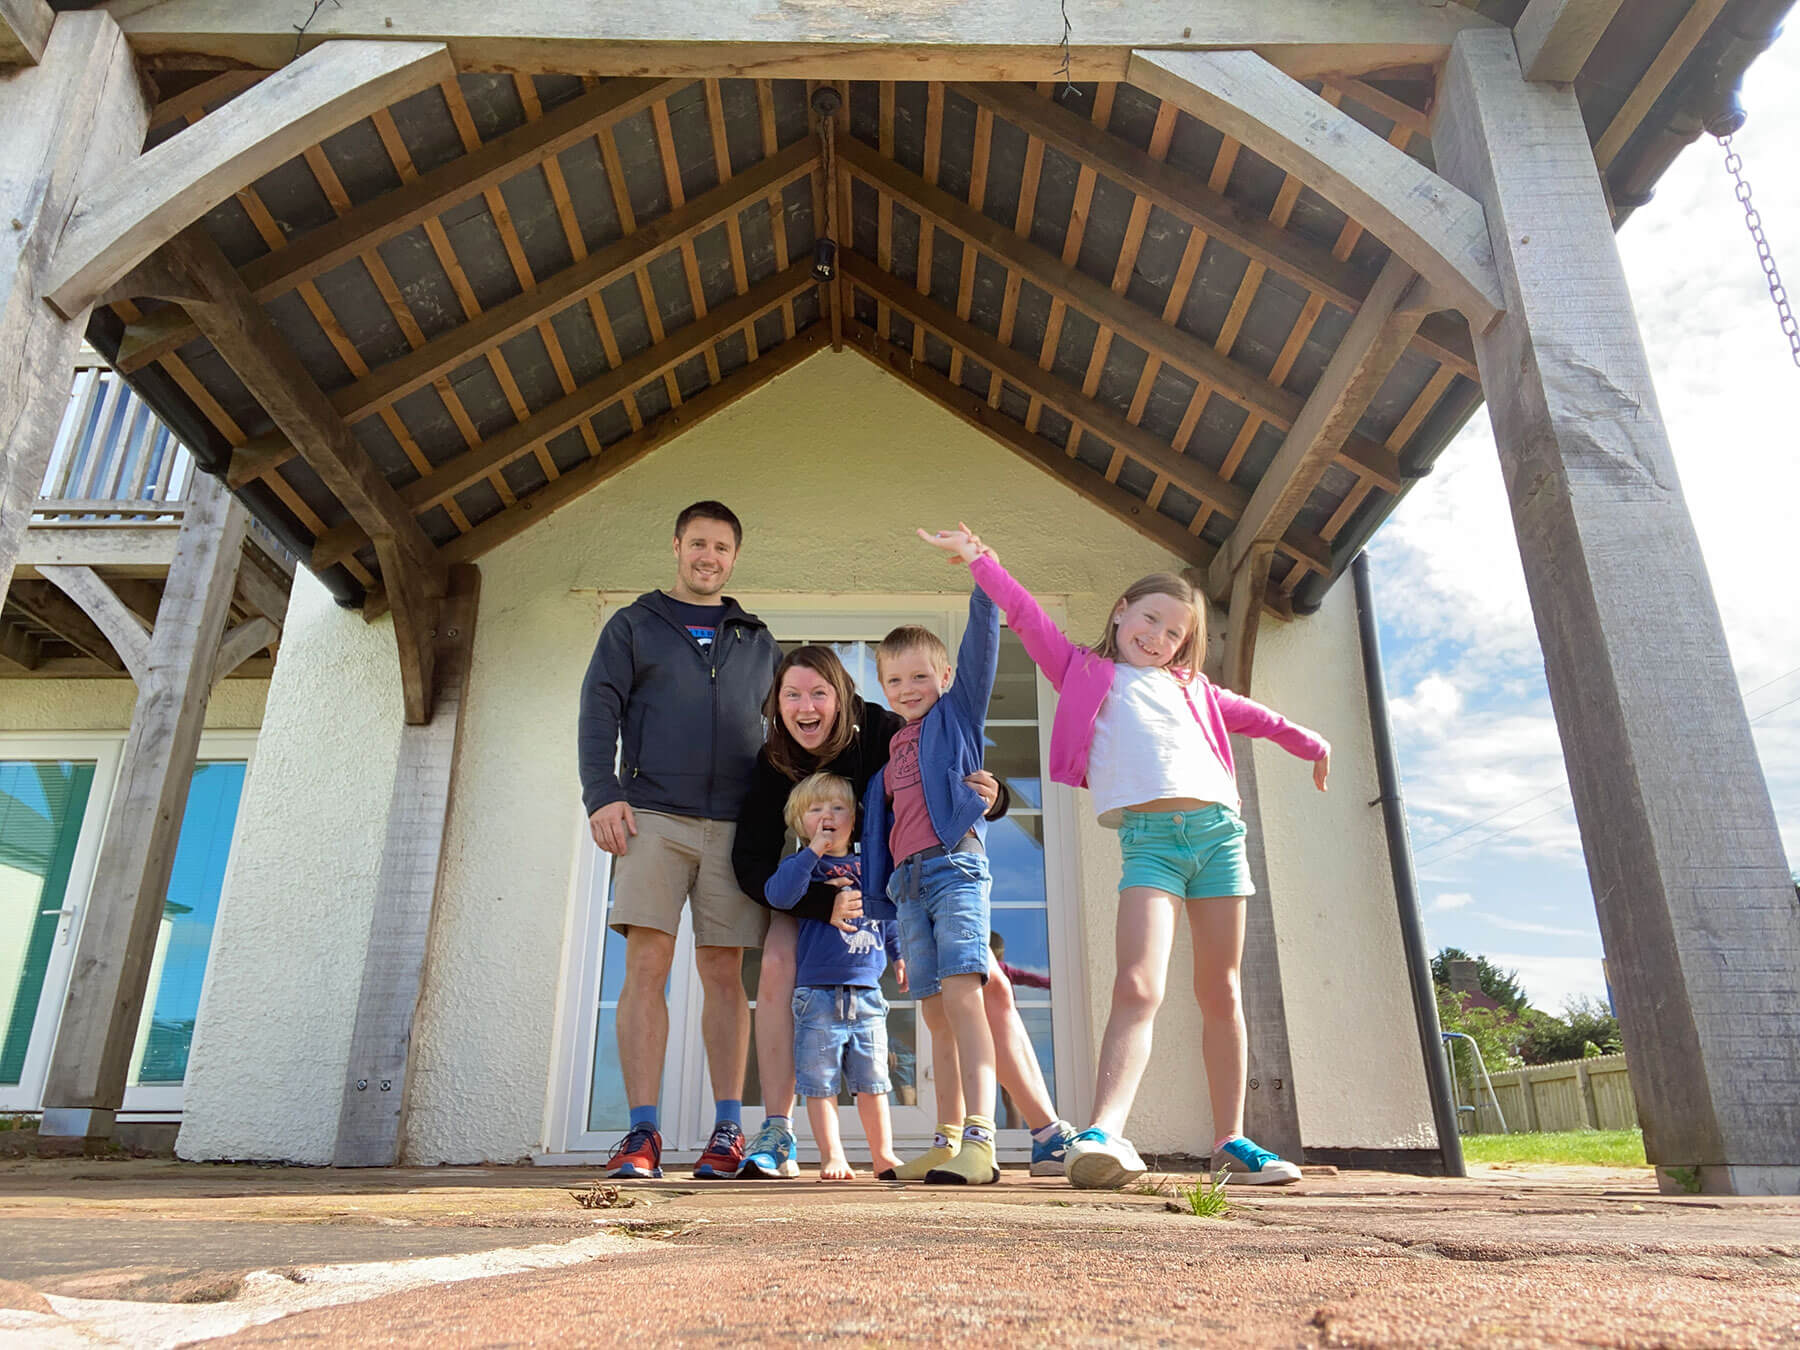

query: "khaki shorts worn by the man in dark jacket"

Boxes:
[607, 812, 769, 947]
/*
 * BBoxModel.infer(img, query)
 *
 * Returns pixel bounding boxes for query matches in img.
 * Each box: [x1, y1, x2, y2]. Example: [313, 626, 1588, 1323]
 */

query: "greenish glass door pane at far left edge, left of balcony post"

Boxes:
[0, 760, 94, 1085]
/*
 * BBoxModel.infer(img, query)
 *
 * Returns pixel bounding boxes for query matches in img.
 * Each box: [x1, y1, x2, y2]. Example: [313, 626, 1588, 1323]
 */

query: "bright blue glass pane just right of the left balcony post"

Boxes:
[131, 761, 245, 1084]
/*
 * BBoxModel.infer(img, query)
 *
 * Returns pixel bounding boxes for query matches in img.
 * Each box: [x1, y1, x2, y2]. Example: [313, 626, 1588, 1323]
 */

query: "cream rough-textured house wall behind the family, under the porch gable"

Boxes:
[180, 353, 1429, 1163]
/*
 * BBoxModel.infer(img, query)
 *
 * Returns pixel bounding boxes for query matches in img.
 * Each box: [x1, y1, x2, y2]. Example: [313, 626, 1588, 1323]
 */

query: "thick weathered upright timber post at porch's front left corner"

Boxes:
[0, 13, 149, 594]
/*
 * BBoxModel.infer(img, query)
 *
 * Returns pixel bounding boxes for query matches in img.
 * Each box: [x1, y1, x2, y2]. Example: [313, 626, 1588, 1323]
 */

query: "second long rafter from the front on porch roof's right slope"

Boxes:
[837, 137, 1399, 493]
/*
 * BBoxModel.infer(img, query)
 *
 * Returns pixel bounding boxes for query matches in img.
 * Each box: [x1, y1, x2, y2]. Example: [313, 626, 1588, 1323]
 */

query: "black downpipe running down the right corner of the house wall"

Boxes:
[1350, 553, 1469, 1177]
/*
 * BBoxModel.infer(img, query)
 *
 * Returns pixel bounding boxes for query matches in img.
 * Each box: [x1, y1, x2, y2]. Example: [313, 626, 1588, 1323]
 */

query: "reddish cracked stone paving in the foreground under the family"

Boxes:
[0, 1161, 1800, 1346]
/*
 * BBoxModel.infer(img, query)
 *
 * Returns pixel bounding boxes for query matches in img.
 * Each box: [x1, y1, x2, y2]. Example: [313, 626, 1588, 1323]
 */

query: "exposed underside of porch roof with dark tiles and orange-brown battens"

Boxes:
[77, 0, 1786, 608]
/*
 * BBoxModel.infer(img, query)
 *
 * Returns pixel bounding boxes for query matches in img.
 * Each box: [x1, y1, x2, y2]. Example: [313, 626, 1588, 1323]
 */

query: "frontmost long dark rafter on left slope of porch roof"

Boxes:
[115, 79, 682, 374]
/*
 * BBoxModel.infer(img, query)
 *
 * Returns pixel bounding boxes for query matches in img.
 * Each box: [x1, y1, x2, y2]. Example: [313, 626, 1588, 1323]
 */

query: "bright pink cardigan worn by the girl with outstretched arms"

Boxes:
[968, 556, 1330, 787]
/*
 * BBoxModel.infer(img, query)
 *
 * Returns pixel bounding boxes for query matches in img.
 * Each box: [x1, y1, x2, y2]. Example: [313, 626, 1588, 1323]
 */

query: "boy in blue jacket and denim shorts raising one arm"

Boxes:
[862, 527, 1001, 1186]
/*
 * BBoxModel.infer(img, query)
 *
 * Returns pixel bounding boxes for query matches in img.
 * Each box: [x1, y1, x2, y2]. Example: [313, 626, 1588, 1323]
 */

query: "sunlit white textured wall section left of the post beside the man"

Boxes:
[176, 572, 401, 1163]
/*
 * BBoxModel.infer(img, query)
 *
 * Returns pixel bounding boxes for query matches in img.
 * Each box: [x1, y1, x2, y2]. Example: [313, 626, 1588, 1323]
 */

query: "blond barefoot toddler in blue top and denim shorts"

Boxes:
[763, 774, 905, 1181]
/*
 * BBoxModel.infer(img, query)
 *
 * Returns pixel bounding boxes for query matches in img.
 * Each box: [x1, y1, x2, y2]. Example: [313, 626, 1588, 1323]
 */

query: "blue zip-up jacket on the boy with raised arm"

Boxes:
[862, 587, 1001, 918]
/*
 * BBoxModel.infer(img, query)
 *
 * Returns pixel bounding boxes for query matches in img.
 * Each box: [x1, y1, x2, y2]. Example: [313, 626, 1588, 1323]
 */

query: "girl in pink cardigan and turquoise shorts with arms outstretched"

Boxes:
[920, 526, 1330, 1188]
